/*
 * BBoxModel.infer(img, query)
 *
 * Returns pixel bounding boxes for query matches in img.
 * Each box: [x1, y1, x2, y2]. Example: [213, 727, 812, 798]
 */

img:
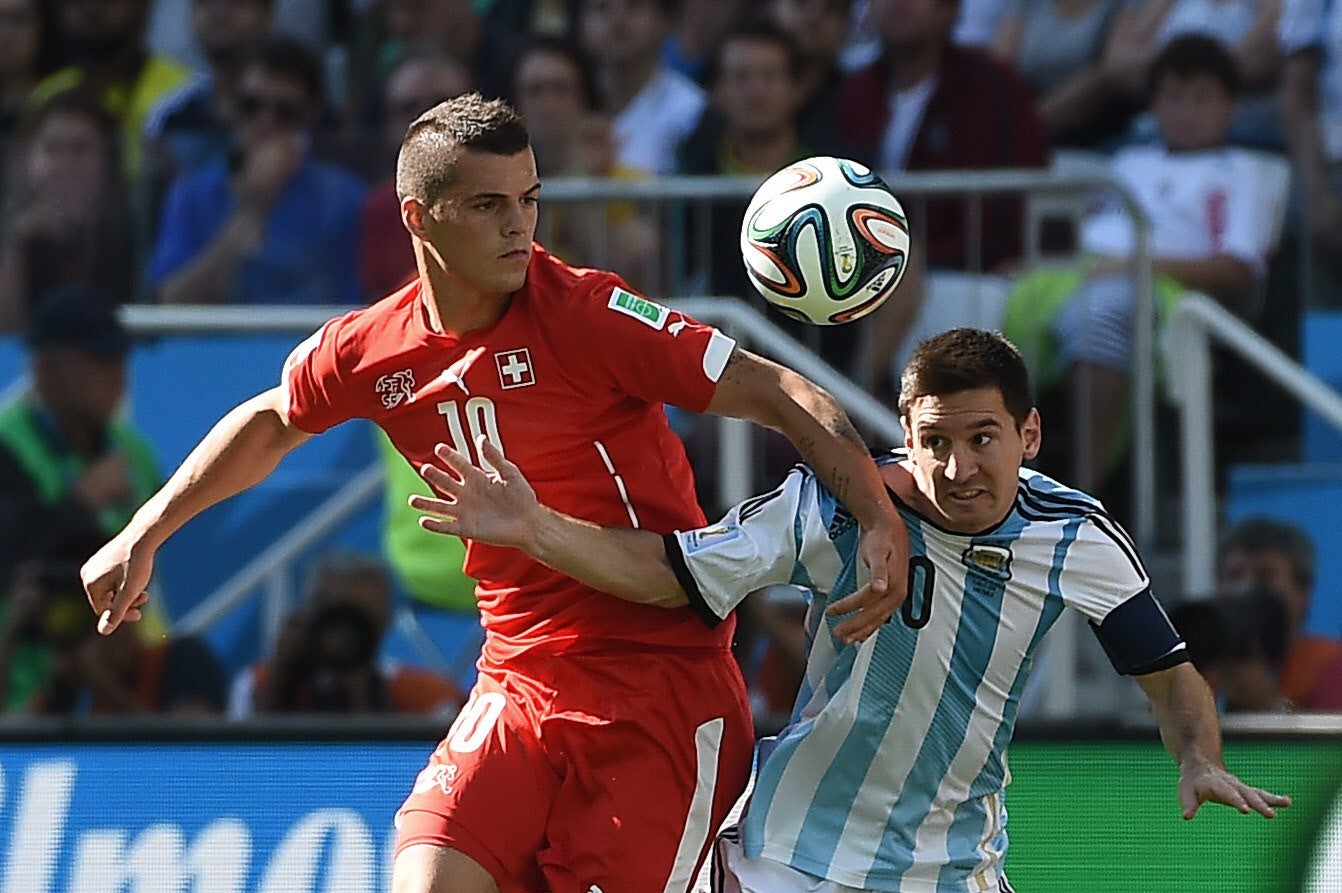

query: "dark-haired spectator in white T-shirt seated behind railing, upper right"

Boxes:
[1005, 35, 1275, 487]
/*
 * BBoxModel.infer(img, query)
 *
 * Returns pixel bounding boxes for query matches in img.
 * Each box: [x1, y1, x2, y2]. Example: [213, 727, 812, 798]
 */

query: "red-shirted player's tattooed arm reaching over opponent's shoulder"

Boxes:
[709, 348, 909, 643]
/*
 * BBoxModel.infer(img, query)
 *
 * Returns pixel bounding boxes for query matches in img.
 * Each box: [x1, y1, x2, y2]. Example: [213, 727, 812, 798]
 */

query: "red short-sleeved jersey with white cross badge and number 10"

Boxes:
[283, 246, 733, 659]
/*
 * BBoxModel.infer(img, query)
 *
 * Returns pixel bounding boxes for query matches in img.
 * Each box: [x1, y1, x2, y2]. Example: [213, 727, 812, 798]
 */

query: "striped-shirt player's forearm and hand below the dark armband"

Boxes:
[1137, 663, 1291, 819]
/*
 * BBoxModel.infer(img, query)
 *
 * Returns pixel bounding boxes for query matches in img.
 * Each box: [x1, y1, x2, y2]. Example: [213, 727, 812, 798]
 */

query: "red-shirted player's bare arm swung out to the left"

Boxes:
[79, 388, 309, 635]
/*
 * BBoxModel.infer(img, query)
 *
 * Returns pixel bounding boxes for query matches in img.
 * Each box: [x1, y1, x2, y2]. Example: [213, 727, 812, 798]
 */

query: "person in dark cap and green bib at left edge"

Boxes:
[0, 287, 161, 585]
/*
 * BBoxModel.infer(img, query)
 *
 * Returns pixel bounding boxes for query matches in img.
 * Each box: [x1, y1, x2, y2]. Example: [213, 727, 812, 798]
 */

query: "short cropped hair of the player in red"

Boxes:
[396, 93, 530, 205]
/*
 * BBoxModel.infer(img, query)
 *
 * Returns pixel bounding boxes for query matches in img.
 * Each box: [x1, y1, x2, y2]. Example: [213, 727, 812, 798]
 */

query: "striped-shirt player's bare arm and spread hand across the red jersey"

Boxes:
[409, 435, 688, 608]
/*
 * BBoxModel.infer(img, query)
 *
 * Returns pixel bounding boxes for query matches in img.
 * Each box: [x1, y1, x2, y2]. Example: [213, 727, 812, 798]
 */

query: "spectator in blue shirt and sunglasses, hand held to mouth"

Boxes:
[149, 36, 366, 305]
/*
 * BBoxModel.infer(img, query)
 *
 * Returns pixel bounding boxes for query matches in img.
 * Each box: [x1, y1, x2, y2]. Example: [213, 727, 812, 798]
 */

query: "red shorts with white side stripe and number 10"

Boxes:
[396, 651, 754, 893]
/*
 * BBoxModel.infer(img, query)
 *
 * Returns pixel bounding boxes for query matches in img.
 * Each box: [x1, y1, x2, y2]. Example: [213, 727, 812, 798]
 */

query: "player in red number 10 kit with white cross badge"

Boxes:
[83, 94, 903, 893]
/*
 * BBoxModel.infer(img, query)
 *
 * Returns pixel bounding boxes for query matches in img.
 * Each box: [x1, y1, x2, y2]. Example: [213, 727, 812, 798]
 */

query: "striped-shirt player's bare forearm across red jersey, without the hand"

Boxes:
[522, 508, 688, 608]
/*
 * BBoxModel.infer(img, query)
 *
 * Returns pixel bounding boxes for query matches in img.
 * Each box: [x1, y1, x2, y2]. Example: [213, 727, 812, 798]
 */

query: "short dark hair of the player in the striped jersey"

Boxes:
[899, 329, 1035, 428]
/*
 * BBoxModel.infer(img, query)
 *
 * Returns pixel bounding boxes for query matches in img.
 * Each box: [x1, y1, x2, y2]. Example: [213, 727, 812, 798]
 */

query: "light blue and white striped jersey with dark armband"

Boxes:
[667, 454, 1184, 893]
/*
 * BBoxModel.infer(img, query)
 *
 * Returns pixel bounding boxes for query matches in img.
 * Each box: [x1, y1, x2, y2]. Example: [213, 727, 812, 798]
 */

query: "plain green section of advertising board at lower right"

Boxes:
[1007, 740, 1342, 893]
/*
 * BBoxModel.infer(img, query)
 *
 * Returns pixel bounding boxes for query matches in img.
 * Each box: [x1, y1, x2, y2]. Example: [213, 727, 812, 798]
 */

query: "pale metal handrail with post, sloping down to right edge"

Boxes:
[1164, 294, 1342, 594]
